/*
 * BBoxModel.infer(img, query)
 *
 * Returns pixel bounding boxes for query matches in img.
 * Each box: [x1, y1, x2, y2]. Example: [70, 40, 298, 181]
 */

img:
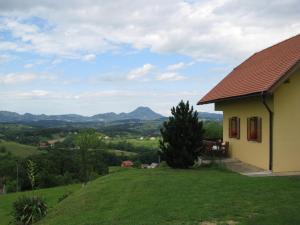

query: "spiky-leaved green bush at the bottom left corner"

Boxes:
[13, 196, 47, 225]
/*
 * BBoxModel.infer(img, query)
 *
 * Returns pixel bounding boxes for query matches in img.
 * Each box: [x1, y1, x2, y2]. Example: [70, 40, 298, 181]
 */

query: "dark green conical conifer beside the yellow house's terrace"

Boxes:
[160, 101, 204, 168]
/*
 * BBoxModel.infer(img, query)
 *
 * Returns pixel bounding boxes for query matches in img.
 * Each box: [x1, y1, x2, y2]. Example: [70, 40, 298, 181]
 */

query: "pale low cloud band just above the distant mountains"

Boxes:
[0, 86, 213, 115]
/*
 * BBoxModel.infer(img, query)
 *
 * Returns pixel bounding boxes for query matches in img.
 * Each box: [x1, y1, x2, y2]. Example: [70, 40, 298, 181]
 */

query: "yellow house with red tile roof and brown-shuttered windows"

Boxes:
[198, 34, 300, 172]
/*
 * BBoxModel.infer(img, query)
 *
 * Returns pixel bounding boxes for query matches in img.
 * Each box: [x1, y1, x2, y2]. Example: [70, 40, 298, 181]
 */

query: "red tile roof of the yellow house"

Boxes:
[198, 34, 300, 104]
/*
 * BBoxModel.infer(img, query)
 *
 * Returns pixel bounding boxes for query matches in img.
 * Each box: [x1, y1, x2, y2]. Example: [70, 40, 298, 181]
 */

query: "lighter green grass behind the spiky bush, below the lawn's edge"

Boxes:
[0, 184, 80, 225]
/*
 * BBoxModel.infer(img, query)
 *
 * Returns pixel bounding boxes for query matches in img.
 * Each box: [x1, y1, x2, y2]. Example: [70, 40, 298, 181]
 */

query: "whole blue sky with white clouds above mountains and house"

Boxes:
[0, 0, 300, 115]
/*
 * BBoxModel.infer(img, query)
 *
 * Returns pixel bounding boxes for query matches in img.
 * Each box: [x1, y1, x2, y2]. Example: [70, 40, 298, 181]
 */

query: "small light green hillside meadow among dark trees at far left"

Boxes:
[0, 140, 38, 157]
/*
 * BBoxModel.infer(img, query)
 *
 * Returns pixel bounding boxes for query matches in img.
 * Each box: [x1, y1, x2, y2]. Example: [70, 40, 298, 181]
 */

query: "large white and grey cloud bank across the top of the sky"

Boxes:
[0, 0, 300, 60]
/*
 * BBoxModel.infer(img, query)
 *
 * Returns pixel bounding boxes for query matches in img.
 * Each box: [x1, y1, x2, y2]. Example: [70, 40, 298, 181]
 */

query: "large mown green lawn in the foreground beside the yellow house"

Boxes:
[39, 169, 300, 225]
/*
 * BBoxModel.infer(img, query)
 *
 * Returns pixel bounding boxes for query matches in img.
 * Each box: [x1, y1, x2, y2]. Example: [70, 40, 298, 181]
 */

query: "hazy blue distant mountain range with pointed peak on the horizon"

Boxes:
[0, 107, 164, 123]
